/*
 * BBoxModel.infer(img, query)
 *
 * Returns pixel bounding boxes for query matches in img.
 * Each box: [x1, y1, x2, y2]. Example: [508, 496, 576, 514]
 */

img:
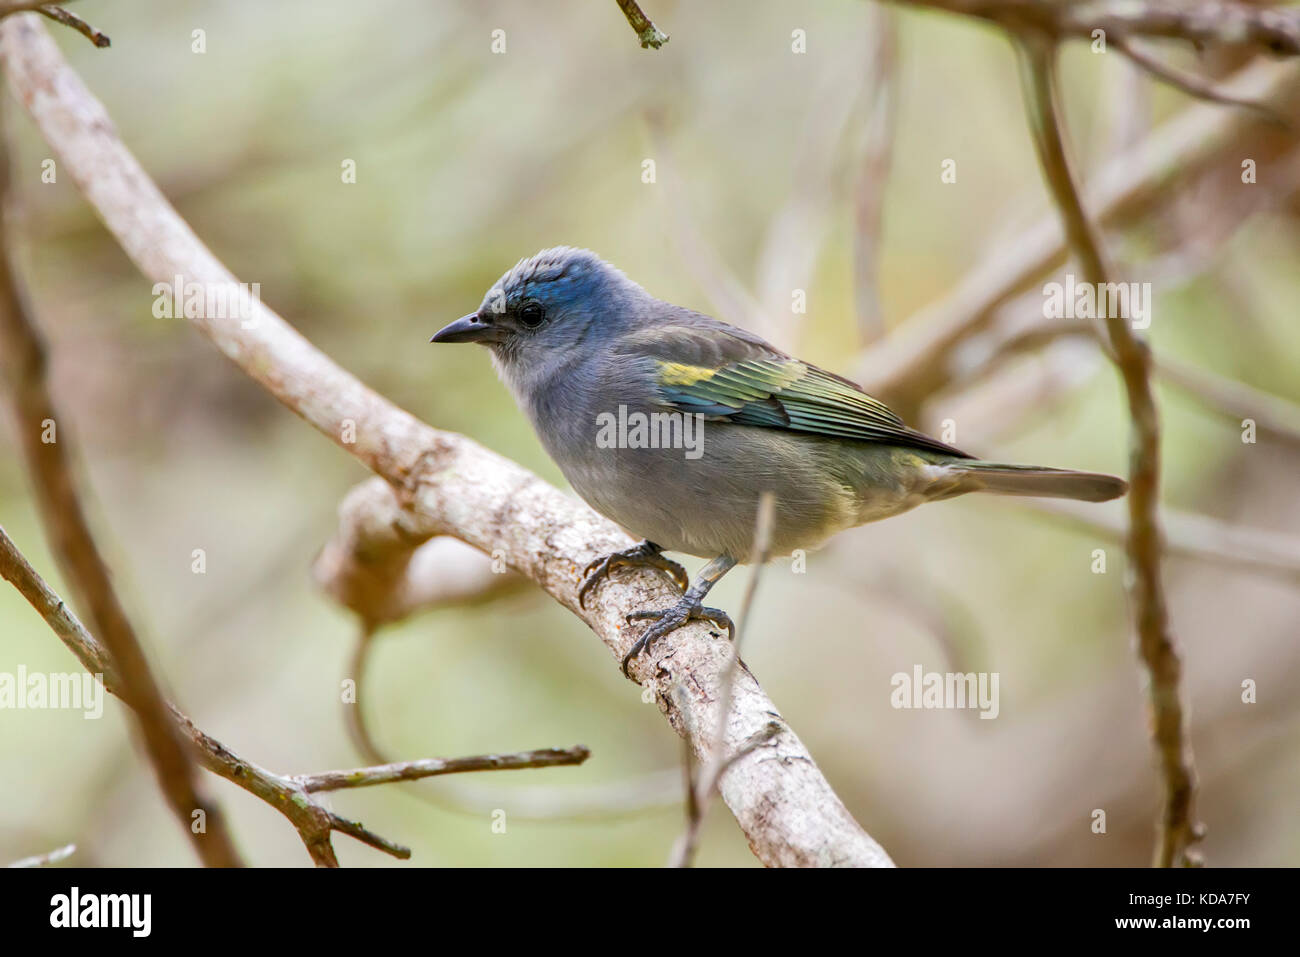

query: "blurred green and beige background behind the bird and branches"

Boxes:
[0, 0, 1300, 866]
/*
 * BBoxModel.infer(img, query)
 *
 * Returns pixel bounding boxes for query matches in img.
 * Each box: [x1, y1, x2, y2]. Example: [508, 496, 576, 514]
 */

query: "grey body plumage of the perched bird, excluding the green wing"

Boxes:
[436, 247, 1125, 560]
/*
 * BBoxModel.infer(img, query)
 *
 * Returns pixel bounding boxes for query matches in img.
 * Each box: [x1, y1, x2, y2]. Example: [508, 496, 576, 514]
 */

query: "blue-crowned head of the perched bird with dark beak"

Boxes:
[429, 246, 649, 364]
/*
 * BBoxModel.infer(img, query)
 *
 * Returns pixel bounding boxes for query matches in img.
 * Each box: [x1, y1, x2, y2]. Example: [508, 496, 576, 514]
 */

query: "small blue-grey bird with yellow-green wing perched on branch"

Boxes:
[430, 246, 1128, 676]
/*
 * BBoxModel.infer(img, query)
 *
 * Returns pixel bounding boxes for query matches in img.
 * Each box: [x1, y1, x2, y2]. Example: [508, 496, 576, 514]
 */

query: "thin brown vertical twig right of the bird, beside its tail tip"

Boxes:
[1018, 35, 1201, 867]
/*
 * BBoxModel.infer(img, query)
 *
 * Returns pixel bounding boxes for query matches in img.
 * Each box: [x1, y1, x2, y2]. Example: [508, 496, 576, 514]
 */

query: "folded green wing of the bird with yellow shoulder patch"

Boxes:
[620, 322, 971, 458]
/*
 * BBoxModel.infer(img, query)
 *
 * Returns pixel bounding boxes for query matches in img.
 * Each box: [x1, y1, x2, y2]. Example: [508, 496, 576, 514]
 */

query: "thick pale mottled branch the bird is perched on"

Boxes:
[0, 17, 889, 866]
